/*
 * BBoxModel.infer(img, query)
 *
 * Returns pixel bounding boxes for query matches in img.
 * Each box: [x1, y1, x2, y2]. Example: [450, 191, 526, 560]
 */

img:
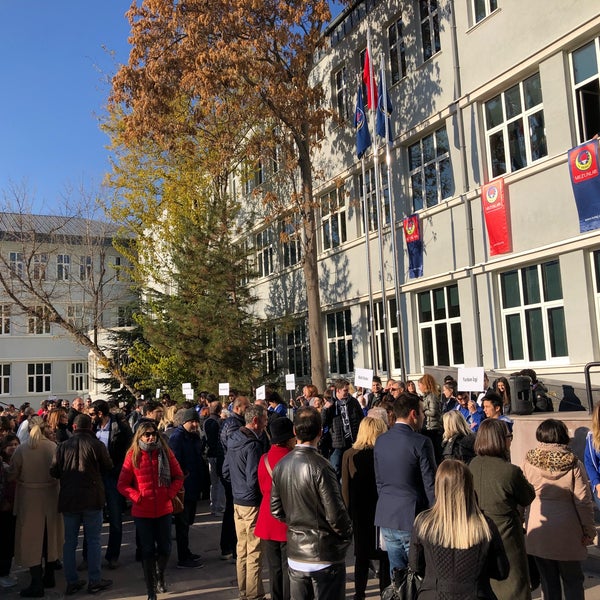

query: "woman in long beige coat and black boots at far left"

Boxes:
[9, 416, 64, 598]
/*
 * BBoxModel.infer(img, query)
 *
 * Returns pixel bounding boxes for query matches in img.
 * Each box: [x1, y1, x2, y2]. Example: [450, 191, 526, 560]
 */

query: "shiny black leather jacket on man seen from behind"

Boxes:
[271, 445, 352, 563]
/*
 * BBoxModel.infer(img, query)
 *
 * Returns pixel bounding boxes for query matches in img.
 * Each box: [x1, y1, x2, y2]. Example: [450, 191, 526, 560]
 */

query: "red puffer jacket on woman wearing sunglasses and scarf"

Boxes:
[117, 450, 183, 519]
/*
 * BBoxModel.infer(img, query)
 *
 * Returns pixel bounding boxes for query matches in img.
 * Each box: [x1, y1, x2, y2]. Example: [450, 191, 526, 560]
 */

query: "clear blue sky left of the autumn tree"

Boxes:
[0, 0, 131, 214]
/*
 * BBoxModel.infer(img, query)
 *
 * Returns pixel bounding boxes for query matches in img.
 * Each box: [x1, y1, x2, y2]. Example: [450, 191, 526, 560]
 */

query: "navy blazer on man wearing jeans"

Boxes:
[374, 423, 437, 531]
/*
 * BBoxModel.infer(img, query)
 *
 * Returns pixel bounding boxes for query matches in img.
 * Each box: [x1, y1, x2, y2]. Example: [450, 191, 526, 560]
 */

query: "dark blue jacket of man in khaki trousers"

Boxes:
[223, 427, 264, 506]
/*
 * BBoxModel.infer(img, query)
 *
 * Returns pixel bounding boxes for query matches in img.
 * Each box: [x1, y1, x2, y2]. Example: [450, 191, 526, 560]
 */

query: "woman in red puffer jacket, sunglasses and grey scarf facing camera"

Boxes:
[117, 421, 183, 600]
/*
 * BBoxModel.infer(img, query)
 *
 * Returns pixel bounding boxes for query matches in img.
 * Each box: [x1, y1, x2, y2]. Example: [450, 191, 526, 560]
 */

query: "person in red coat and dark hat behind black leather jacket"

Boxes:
[254, 417, 296, 600]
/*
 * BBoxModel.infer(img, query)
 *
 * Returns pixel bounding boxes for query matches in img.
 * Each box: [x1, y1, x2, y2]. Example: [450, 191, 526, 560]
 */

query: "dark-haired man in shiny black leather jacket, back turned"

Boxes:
[271, 407, 352, 600]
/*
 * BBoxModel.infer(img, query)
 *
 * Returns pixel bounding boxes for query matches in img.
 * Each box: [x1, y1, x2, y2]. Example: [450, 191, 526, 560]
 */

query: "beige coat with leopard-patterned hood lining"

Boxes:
[523, 443, 596, 561]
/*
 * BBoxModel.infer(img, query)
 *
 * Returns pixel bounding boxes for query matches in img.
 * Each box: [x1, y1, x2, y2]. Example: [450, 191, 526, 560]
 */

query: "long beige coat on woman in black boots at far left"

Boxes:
[10, 439, 64, 567]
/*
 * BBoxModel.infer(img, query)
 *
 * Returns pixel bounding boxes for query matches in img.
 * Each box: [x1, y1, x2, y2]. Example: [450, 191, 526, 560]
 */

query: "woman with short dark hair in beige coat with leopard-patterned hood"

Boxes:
[523, 419, 596, 600]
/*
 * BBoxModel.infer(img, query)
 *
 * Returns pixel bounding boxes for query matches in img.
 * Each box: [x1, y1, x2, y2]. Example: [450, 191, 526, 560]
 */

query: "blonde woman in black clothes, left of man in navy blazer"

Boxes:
[342, 417, 390, 600]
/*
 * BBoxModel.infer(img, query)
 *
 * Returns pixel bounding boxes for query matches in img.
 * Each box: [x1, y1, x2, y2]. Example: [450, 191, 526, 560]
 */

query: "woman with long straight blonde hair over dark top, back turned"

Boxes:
[408, 459, 509, 600]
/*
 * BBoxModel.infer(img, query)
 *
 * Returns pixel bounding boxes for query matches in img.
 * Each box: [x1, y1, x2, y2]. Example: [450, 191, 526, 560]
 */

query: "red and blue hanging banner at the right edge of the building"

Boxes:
[569, 139, 600, 233]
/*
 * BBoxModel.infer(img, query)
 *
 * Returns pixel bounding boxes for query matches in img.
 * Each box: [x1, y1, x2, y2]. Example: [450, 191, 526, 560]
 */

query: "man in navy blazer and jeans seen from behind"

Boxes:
[374, 392, 437, 572]
